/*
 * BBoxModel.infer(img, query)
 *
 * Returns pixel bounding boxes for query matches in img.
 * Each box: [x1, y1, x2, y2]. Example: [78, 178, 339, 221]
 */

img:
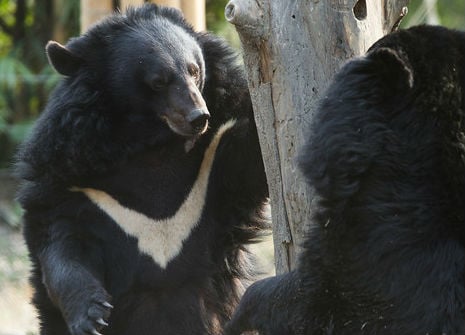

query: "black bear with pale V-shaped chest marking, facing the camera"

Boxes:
[17, 4, 268, 335]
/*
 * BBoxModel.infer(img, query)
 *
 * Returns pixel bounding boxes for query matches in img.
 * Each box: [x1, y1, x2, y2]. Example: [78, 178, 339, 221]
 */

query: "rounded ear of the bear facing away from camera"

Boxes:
[367, 47, 414, 88]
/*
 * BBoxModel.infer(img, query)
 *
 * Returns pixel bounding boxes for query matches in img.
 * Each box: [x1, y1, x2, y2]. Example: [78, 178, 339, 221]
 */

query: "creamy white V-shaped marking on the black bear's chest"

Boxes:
[71, 120, 236, 269]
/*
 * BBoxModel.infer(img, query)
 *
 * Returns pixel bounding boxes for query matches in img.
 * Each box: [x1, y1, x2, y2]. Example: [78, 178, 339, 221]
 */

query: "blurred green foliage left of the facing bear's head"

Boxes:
[0, 0, 79, 168]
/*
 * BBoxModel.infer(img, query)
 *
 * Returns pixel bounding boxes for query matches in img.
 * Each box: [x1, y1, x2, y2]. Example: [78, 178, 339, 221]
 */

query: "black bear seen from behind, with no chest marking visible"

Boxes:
[225, 26, 465, 335]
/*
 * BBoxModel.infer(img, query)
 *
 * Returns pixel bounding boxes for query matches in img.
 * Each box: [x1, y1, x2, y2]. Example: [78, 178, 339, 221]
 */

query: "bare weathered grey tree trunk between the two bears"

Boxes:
[225, 0, 408, 273]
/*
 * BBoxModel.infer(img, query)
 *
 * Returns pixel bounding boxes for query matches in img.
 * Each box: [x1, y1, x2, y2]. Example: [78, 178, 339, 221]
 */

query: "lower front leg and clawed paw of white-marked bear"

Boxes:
[39, 237, 113, 335]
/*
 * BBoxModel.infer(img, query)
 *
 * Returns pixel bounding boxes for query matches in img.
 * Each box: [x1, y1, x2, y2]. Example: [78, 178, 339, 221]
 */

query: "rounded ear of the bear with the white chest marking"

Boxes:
[45, 41, 82, 76]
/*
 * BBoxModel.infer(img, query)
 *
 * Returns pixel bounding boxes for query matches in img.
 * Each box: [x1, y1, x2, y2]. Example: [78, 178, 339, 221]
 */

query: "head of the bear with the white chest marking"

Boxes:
[46, 5, 210, 142]
